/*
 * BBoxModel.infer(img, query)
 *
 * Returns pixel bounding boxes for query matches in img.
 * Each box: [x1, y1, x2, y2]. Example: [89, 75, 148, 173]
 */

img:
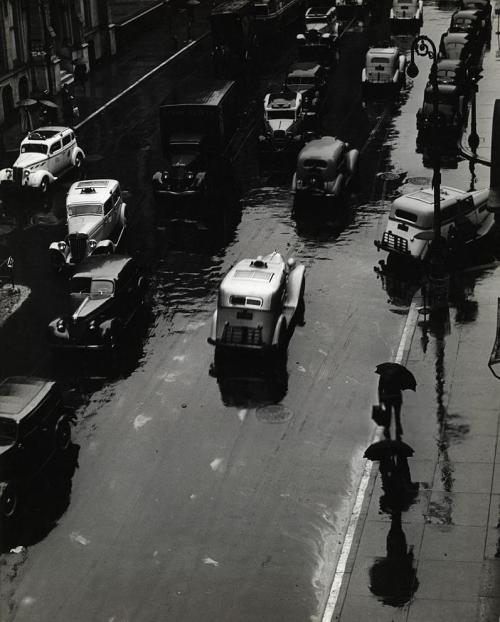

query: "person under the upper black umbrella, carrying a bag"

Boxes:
[375, 363, 417, 440]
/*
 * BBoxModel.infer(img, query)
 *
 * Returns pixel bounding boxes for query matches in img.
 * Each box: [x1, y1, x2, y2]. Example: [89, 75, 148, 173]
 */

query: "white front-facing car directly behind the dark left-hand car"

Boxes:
[49, 179, 127, 270]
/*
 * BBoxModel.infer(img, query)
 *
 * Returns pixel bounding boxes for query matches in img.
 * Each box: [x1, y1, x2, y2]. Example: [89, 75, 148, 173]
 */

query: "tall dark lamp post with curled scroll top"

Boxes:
[406, 35, 449, 309]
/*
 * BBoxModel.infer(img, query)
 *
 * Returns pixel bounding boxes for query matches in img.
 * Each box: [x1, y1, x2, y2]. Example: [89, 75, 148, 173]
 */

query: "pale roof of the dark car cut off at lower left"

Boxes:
[0, 376, 56, 423]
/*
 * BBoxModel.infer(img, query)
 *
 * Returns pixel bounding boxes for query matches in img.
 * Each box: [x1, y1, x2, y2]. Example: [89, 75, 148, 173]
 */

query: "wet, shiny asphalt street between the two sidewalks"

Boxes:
[0, 4, 498, 622]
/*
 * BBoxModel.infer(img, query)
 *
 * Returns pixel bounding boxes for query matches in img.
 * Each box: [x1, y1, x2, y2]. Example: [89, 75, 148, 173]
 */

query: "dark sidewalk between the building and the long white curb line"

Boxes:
[0, 2, 209, 167]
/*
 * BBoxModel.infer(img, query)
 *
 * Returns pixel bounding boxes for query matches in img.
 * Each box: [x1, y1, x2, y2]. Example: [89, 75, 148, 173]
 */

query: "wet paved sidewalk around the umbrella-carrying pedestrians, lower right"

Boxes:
[332, 267, 500, 622]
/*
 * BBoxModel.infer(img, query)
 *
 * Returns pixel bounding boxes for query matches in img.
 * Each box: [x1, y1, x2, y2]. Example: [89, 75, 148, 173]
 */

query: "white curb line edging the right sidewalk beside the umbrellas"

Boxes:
[322, 302, 418, 622]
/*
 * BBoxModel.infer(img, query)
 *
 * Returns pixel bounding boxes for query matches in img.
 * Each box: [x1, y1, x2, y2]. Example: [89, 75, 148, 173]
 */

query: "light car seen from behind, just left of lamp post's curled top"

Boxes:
[361, 47, 406, 95]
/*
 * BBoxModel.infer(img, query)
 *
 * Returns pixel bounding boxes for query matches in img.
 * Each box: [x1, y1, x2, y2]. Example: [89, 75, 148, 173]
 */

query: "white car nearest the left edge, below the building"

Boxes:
[0, 126, 85, 193]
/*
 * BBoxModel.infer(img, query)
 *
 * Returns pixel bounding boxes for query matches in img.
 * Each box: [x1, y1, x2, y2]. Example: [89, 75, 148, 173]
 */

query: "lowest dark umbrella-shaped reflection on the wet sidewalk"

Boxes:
[369, 512, 419, 607]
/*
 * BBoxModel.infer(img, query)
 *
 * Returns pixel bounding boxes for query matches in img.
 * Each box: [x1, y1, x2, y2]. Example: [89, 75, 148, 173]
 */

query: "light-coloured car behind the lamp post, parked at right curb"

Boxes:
[375, 186, 494, 261]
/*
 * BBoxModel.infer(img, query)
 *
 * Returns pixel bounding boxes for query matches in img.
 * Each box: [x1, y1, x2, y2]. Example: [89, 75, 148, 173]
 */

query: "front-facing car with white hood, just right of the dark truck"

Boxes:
[259, 90, 304, 152]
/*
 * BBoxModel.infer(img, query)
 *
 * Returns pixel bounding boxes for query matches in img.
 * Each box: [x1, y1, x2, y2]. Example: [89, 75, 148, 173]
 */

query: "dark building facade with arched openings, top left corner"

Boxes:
[0, 0, 116, 124]
